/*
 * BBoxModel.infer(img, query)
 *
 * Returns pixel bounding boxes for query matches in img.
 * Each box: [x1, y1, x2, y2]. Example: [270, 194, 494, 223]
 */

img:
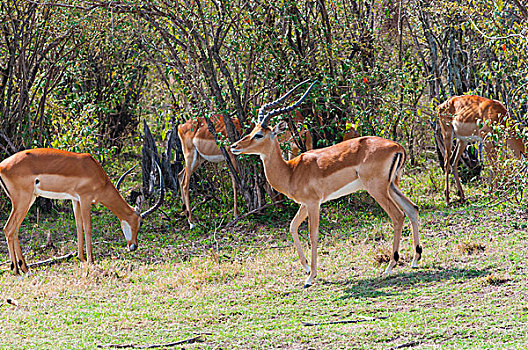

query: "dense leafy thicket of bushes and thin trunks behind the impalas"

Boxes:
[0, 0, 528, 208]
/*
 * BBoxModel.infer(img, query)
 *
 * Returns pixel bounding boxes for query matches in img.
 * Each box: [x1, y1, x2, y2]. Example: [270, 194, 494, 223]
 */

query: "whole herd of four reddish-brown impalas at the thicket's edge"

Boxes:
[0, 82, 527, 287]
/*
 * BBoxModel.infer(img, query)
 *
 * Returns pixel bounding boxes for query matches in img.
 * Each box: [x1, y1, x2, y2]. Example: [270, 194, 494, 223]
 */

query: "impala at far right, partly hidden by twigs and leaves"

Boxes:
[438, 95, 526, 204]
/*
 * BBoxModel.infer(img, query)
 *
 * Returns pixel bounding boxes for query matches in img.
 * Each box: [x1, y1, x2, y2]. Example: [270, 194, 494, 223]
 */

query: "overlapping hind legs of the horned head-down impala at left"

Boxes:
[4, 196, 35, 276]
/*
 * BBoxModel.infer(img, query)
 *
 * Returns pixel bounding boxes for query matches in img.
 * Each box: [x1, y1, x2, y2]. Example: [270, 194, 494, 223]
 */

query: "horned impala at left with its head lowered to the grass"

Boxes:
[0, 148, 164, 275]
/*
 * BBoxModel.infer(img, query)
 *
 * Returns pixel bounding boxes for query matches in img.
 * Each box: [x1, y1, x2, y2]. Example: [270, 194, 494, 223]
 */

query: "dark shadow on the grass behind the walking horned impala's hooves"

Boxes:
[330, 268, 489, 299]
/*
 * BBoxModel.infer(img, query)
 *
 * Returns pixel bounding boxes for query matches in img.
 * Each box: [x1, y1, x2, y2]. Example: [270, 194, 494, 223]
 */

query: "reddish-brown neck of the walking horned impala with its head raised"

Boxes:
[260, 137, 293, 196]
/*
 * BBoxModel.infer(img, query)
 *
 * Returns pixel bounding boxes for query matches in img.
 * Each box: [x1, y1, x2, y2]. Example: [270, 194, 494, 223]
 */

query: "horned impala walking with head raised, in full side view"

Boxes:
[231, 83, 422, 287]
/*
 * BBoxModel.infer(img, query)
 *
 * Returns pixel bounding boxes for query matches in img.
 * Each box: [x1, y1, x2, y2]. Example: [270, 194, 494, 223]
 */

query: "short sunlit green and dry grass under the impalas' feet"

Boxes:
[0, 166, 528, 349]
